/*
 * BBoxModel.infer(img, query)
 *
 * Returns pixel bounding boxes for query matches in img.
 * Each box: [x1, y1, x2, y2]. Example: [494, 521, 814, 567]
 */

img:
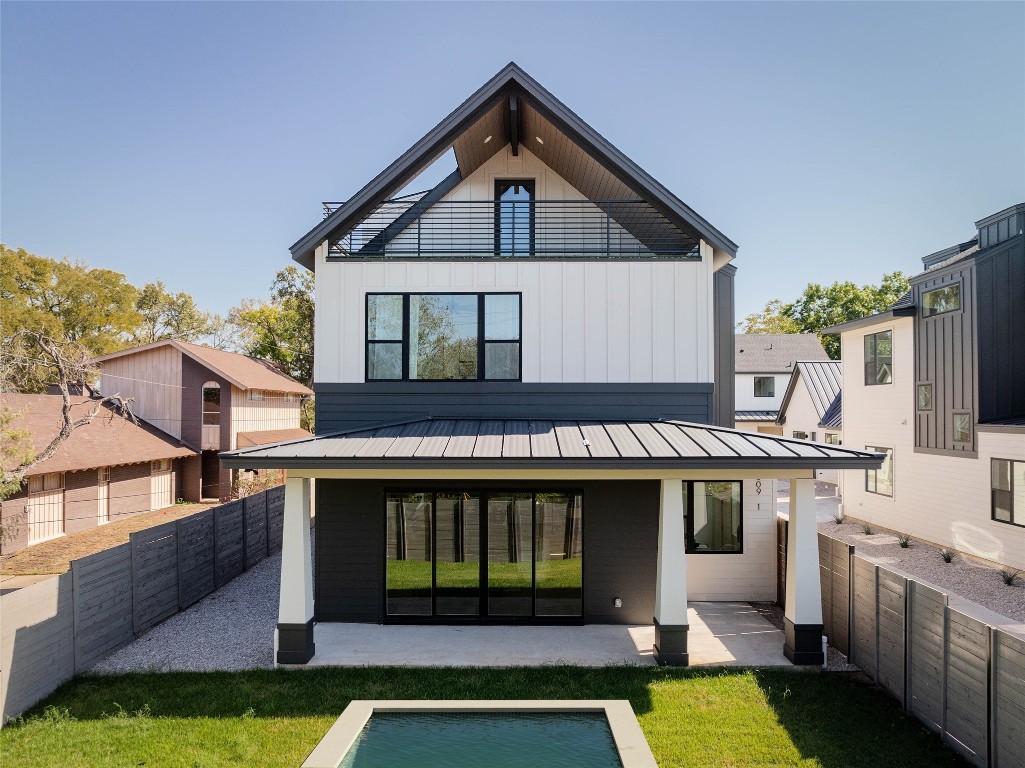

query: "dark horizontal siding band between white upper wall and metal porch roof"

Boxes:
[315, 381, 713, 435]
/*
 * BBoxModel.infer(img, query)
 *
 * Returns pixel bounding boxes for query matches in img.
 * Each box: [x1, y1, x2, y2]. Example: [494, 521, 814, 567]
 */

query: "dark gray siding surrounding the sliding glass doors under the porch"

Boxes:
[316, 480, 659, 624]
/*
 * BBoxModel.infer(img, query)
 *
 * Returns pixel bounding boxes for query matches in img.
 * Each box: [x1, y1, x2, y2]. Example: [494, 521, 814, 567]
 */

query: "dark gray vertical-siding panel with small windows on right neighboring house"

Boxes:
[918, 259, 978, 455]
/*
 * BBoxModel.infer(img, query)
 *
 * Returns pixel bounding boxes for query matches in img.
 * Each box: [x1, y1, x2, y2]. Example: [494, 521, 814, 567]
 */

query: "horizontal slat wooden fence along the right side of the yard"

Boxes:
[799, 534, 1025, 768]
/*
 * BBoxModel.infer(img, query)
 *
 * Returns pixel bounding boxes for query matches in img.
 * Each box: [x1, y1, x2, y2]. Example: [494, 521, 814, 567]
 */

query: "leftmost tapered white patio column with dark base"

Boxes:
[274, 478, 314, 664]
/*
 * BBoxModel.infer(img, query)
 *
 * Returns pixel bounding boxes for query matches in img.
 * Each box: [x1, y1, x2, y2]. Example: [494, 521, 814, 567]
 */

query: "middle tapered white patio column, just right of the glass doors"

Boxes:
[654, 480, 690, 666]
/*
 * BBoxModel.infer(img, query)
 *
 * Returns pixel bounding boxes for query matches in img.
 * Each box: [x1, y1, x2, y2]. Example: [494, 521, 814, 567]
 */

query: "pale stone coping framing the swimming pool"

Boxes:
[302, 699, 658, 768]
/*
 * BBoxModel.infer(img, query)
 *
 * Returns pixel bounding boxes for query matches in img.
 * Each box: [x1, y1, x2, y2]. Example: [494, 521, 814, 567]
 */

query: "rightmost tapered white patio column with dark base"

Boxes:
[783, 478, 822, 665]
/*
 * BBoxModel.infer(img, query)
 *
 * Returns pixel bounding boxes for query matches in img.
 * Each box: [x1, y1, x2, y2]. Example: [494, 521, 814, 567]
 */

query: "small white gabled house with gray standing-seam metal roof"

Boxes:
[776, 360, 844, 485]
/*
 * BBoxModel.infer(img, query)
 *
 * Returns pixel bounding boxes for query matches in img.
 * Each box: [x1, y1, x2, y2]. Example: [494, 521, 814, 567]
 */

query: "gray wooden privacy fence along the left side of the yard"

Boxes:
[0, 486, 285, 723]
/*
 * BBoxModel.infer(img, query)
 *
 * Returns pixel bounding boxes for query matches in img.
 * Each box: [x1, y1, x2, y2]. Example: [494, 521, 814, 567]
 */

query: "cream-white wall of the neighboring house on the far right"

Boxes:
[842, 318, 1025, 568]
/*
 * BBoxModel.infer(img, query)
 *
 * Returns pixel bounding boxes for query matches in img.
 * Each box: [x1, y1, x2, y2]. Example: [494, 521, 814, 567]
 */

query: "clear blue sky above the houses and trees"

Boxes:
[0, 2, 1025, 318]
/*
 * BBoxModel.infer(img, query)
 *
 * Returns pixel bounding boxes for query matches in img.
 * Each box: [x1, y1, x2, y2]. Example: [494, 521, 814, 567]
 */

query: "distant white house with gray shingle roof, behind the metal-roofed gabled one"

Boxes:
[734, 333, 829, 435]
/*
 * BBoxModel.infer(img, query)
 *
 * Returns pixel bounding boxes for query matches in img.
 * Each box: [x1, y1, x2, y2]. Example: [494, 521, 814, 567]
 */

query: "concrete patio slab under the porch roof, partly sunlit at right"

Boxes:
[306, 603, 790, 666]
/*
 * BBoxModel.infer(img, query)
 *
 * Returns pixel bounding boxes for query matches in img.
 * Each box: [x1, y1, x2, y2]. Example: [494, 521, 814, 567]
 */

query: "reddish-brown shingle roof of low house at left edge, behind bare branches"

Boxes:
[0, 393, 196, 475]
